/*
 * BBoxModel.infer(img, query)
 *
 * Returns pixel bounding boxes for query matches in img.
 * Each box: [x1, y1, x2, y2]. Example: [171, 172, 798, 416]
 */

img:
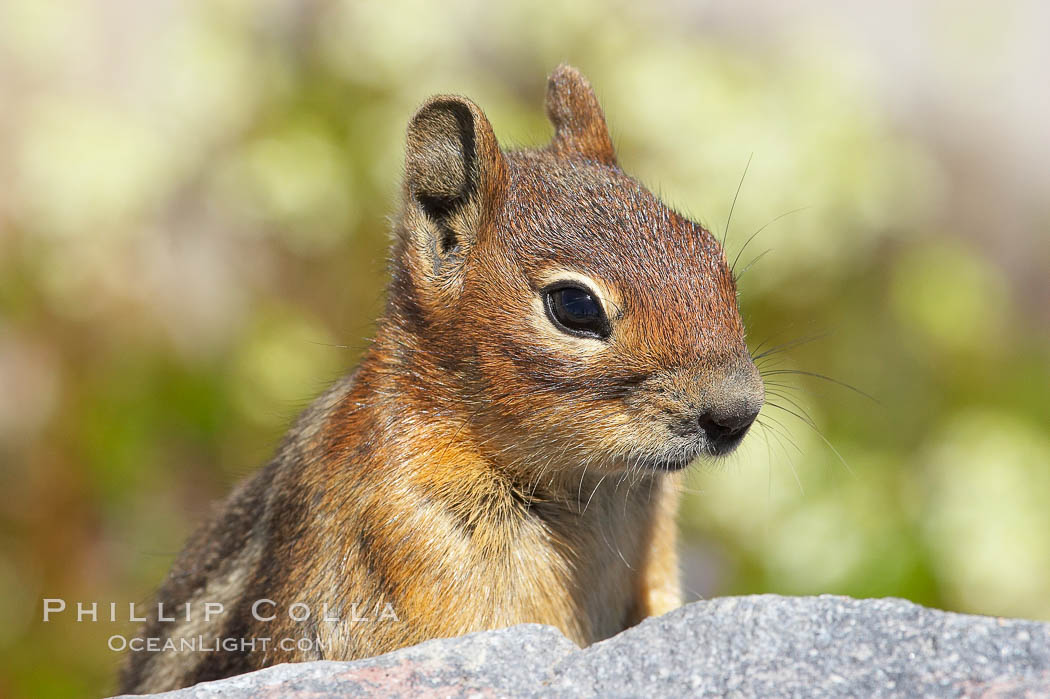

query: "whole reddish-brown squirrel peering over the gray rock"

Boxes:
[121, 65, 764, 693]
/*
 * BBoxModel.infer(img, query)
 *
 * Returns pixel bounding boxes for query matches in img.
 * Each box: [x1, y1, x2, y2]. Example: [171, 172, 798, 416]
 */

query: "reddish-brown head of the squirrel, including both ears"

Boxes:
[387, 66, 764, 473]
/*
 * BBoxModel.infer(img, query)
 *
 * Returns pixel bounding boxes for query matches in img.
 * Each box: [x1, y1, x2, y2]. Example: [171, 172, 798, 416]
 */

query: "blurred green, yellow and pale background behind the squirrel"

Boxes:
[0, 0, 1050, 697]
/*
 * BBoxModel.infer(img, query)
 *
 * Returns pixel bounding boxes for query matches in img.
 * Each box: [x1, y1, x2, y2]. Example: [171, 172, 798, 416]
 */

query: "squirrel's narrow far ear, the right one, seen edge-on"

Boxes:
[547, 64, 616, 165]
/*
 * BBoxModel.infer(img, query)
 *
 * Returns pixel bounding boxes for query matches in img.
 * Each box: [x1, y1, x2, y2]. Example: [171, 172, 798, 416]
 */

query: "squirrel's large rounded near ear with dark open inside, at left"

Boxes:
[405, 96, 507, 269]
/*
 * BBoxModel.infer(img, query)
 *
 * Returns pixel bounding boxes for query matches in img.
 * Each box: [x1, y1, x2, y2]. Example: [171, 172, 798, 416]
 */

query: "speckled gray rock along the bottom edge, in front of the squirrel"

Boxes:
[112, 595, 1050, 699]
